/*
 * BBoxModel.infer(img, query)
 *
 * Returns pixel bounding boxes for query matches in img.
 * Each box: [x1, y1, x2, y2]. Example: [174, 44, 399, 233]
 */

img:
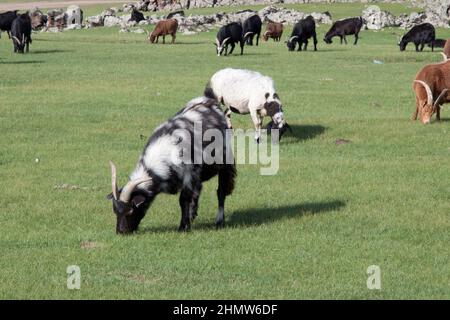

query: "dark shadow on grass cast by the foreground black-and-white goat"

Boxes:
[139, 200, 346, 233]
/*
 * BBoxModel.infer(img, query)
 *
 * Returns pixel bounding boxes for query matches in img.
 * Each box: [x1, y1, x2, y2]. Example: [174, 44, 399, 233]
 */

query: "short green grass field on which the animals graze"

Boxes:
[0, 5, 450, 299]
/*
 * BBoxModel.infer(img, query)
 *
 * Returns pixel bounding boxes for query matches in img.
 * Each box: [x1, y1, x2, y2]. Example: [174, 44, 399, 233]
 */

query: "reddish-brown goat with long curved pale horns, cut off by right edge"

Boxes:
[412, 60, 450, 124]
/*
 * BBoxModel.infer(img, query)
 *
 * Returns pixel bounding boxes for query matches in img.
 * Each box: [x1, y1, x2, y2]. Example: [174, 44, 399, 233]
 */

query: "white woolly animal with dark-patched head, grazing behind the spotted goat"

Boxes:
[205, 68, 287, 143]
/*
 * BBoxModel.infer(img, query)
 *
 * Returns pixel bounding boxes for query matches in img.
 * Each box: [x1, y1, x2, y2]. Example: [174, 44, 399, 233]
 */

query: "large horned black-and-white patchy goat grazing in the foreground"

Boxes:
[108, 97, 236, 234]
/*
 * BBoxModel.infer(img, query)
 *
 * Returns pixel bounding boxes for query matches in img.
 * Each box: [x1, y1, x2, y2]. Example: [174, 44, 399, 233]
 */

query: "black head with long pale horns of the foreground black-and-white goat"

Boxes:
[108, 161, 153, 234]
